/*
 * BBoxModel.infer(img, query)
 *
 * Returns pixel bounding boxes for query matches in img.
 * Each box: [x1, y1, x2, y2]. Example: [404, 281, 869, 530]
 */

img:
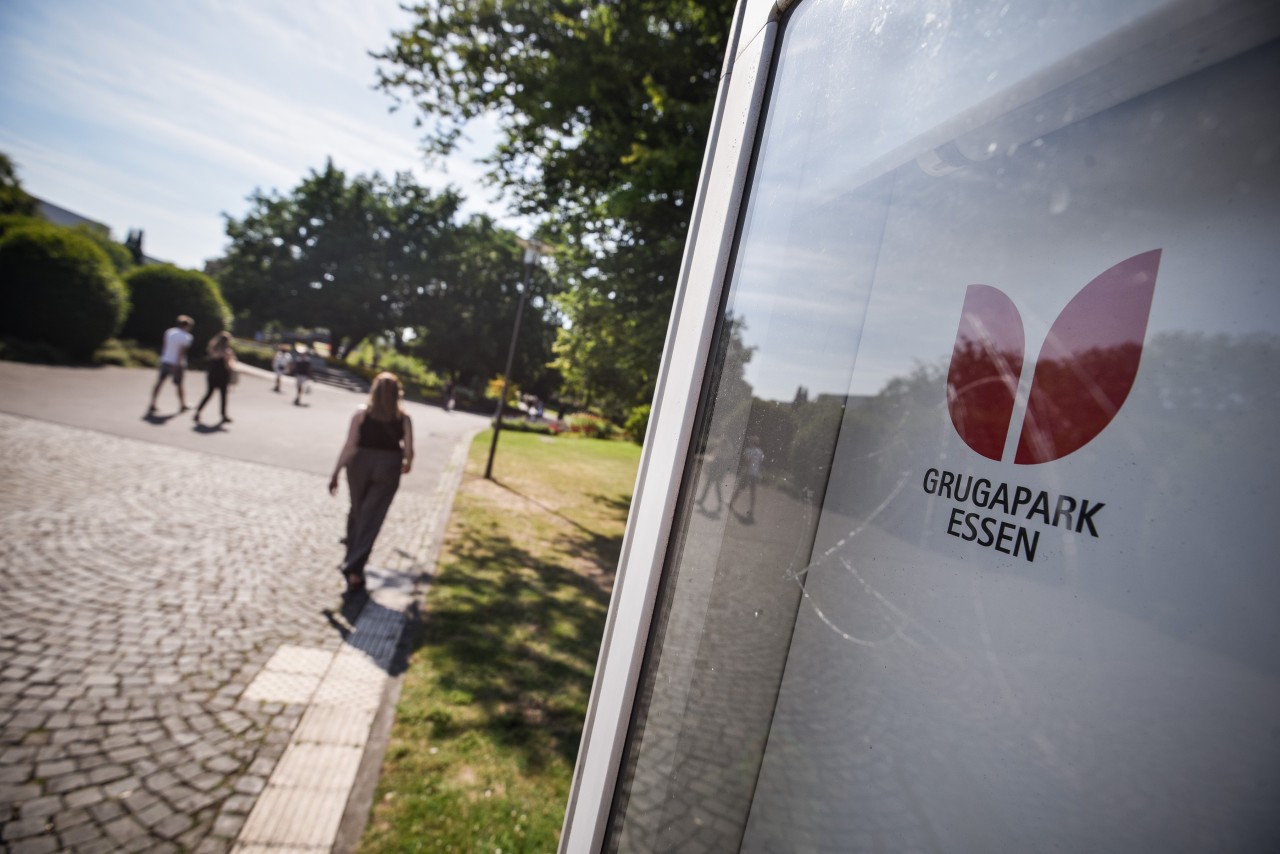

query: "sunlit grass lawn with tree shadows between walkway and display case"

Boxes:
[361, 431, 640, 854]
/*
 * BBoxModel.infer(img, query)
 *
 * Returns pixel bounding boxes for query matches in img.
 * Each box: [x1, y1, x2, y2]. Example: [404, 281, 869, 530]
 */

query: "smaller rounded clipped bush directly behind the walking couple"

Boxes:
[122, 264, 232, 353]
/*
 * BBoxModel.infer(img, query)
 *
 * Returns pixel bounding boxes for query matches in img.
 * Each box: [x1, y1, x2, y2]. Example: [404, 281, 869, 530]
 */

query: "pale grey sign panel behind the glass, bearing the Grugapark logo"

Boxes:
[741, 5, 1280, 851]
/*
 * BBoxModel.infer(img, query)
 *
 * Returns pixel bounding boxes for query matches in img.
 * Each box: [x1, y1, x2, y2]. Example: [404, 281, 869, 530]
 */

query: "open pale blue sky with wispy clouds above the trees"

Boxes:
[0, 0, 518, 269]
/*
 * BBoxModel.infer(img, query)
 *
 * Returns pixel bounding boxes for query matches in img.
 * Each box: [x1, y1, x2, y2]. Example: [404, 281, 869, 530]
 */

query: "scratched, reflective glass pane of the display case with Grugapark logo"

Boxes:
[609, 0, 1280, 851]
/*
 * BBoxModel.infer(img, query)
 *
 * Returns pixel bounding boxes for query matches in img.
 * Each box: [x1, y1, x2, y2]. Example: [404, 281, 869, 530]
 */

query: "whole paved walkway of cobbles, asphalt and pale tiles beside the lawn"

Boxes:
[0, 362, 484, 854]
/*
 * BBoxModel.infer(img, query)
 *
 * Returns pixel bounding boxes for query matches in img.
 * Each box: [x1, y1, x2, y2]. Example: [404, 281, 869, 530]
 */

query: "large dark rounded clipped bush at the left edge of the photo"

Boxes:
[0, 224, 129, 360]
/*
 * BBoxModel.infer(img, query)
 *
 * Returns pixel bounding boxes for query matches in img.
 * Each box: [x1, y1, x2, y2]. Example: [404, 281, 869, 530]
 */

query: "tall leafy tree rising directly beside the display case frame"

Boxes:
[378, 0, 735, 411]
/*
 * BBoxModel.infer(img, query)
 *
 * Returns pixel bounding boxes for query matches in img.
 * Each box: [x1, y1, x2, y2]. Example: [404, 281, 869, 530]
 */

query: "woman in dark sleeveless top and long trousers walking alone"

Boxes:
[329, 371, 413, 602]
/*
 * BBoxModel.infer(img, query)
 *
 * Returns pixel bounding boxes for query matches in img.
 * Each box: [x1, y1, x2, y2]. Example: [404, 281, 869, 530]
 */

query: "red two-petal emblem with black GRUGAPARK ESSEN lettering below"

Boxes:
[923, 250, 1161, 561]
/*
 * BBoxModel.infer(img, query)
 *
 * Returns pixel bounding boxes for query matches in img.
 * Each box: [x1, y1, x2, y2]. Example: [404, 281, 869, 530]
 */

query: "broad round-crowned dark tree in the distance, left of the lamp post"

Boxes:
[219, 161, 461, 348]
